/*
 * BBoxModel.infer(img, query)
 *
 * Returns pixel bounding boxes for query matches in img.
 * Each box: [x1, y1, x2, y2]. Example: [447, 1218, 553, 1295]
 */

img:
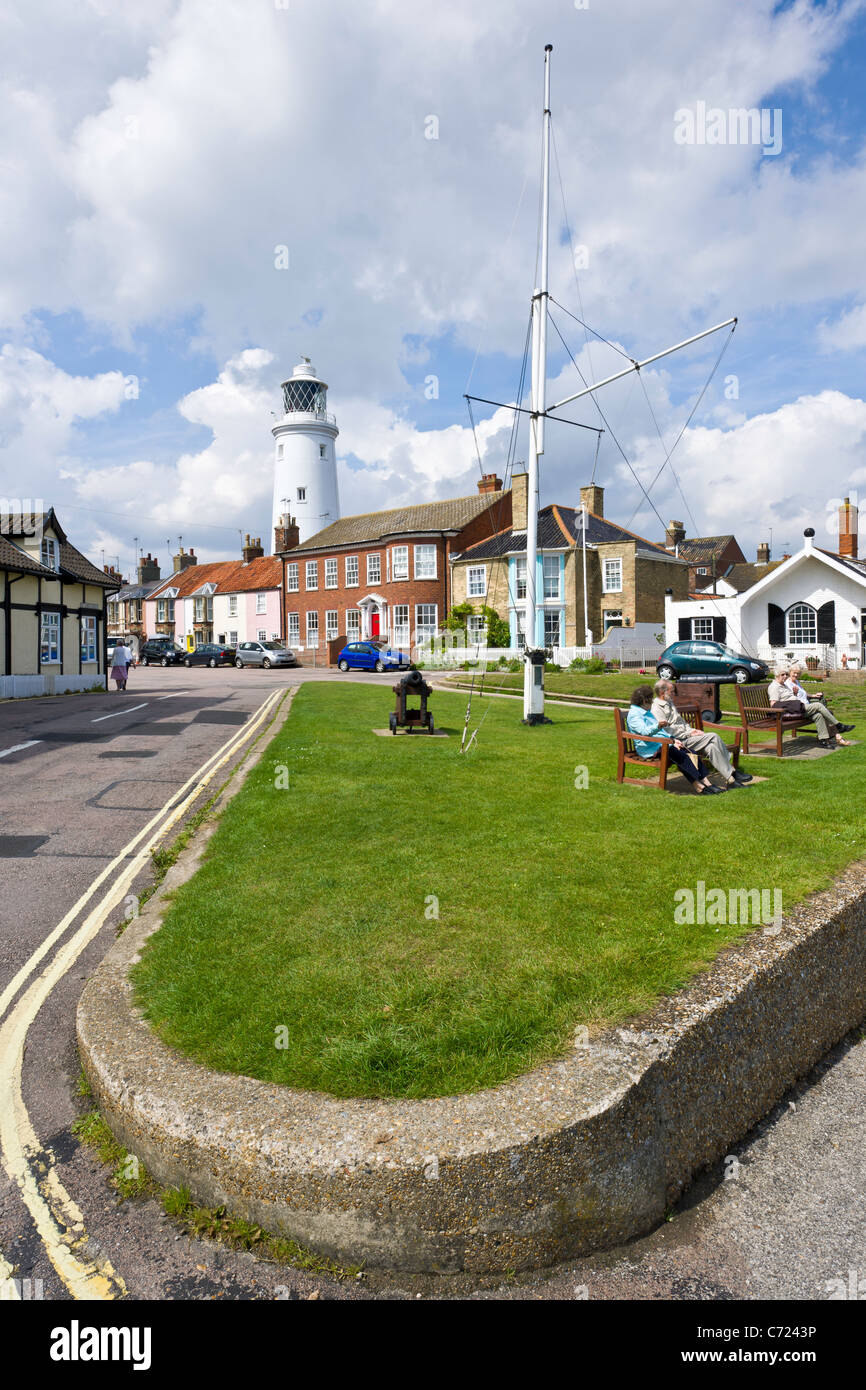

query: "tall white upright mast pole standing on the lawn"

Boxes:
[523, 43, 553, 724]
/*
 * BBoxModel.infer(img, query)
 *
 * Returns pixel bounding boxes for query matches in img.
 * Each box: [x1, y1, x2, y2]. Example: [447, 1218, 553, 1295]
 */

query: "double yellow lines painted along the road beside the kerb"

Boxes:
[0, 691, 285, 1300]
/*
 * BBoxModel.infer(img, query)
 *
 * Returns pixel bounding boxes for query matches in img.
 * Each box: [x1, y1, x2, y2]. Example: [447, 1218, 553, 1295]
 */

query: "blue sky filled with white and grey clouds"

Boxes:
[0, 0, 866, 575]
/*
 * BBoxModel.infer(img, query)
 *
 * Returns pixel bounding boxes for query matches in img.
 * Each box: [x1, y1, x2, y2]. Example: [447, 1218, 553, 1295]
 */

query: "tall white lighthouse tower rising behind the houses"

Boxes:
[271, 357, 339, 541]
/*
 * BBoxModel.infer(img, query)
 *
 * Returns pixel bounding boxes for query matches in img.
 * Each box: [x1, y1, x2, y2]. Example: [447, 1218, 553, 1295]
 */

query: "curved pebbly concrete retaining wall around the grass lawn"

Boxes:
[78, 686, 866, 1273]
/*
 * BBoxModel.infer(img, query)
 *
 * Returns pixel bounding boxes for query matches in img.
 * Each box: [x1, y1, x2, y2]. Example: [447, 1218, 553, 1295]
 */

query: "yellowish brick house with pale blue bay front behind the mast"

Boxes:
[452, 473, 688, 648]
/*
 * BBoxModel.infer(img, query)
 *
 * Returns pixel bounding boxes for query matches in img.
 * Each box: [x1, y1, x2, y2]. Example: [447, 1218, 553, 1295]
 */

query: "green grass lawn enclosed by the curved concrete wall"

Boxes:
[133, 682, 866, 1097]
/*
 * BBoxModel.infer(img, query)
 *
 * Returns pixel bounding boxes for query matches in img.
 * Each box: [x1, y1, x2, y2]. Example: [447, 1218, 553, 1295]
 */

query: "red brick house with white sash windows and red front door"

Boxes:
[275, 474, 512, 649]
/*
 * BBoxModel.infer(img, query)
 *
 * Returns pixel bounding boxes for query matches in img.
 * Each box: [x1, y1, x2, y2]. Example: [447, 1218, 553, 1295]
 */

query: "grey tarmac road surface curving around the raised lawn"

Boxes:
[0, 667, 866, 1301]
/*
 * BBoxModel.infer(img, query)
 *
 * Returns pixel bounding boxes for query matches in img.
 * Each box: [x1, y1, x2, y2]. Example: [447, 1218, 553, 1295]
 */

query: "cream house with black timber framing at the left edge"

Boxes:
[0, 507, 120, 698]
